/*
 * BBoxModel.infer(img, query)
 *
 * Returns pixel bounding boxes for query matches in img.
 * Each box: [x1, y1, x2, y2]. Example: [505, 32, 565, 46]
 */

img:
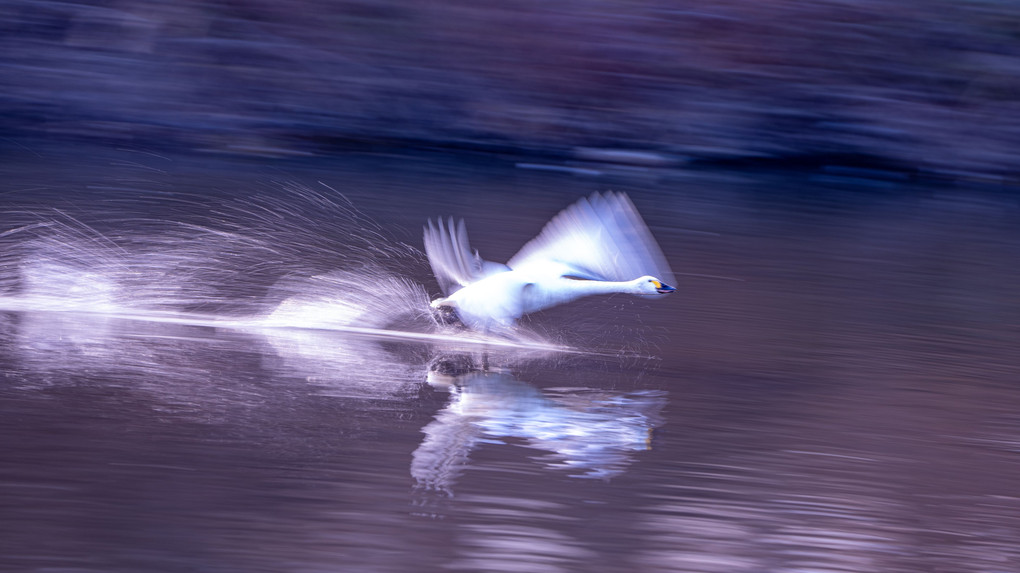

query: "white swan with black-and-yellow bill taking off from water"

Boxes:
[424, 192, 676, 332]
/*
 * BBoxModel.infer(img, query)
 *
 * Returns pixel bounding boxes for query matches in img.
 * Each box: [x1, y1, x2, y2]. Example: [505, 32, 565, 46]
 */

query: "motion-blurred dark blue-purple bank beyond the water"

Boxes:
[0, 0, 1020, 179]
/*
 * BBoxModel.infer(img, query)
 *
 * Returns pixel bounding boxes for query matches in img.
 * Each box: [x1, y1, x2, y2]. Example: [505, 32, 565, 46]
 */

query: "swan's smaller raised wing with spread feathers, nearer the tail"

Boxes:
[424, 217, 510, 296]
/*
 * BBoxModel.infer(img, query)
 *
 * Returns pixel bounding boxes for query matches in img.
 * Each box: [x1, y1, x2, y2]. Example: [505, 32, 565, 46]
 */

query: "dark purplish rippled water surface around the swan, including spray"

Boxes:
[0, 145, 1020, 572]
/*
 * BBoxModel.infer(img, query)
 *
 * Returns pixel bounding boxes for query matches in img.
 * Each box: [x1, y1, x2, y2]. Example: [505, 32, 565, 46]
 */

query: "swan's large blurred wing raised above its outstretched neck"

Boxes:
[507, 193, 675, 284]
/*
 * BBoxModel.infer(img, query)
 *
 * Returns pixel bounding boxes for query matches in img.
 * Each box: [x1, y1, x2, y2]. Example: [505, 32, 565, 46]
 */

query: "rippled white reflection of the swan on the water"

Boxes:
[411, 357, 665, 494]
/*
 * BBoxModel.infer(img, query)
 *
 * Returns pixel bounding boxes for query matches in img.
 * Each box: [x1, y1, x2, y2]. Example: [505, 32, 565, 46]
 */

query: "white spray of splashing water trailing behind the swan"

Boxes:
[0, 184, 567, 348]
